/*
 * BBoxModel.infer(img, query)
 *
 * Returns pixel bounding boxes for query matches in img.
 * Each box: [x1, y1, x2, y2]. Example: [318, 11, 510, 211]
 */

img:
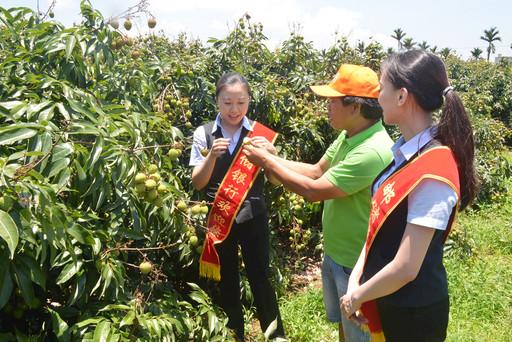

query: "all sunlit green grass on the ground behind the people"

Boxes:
[258, 199, 512, 342]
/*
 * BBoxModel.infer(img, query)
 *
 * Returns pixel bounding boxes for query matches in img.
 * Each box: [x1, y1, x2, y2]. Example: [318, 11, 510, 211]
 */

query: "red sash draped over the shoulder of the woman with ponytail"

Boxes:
[361, 146, 460, 341]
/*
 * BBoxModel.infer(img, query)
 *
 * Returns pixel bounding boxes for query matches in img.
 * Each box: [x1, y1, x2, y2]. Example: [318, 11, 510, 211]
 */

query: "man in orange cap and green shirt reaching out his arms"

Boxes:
[244, 64, 393, 341]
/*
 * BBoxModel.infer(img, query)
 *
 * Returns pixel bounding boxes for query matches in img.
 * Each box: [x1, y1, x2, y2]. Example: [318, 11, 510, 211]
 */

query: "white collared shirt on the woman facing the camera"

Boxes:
[189, 113, 252, 166]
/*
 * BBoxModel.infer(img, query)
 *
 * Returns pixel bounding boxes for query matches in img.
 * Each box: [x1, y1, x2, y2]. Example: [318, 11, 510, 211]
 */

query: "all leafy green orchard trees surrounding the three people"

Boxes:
[0, 1, 512, 341]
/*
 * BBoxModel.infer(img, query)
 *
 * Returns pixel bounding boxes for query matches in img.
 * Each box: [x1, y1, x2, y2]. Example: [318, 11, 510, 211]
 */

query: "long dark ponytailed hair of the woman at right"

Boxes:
[382, 50, 478, 210]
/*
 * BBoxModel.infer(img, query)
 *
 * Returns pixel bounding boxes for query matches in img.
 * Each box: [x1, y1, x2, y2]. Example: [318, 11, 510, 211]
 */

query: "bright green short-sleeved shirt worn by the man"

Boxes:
[322, 121, 393, 267]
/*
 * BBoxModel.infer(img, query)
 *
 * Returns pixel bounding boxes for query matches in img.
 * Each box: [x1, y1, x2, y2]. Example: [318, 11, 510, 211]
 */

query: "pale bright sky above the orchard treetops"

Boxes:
[0, 0, 512, 58]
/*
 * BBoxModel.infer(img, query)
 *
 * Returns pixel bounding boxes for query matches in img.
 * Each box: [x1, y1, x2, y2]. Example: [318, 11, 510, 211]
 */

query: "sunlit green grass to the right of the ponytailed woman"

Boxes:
[445, 200, 512, 341]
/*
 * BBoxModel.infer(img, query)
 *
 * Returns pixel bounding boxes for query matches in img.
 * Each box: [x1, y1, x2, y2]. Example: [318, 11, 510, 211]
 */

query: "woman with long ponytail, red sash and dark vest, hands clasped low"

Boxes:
[340, 50, 477, 342]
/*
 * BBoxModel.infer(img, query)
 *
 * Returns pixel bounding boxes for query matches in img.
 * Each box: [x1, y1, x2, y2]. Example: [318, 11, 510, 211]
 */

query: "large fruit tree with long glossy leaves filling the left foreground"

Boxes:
[0, 1, 227, 340]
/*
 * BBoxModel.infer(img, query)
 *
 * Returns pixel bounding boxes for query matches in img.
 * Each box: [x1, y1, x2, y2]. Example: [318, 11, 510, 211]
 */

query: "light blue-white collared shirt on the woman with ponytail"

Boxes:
[372, 128, 458, 230]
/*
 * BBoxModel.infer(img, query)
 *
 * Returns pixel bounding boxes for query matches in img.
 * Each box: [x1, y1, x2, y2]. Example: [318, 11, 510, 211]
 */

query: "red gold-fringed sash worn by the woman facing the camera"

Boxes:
[199, 121, 277, 281]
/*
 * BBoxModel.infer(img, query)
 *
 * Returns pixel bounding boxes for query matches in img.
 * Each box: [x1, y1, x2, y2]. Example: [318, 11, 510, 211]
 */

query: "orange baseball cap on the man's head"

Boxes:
[310, 64, 380, 99]
